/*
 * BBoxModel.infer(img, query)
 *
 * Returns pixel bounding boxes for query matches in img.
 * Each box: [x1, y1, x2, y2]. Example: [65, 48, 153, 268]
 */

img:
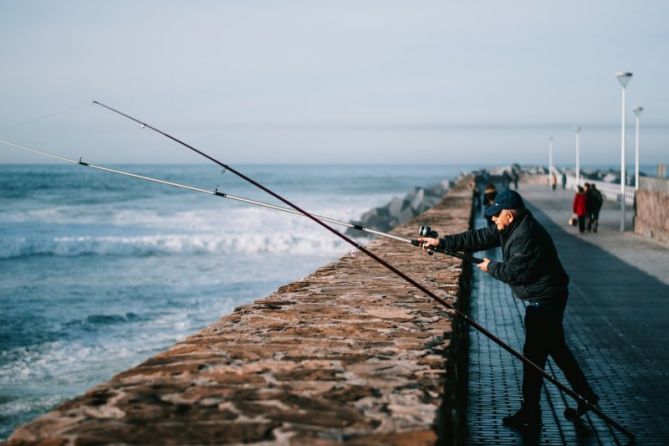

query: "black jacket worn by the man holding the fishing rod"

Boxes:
[439, 210, 569, 299]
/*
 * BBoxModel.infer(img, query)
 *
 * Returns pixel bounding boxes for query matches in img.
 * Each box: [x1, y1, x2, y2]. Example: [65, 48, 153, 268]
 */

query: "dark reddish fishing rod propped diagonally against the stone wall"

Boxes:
[93, 101, 636, 444]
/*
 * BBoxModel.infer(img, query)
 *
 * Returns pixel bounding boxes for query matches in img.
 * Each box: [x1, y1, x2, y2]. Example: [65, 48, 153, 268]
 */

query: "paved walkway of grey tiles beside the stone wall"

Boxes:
[467, 184, 669, 445]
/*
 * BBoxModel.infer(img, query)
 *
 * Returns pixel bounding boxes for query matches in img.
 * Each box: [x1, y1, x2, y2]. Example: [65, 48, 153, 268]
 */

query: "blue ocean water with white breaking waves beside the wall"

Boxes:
[0, 165, 473, 439]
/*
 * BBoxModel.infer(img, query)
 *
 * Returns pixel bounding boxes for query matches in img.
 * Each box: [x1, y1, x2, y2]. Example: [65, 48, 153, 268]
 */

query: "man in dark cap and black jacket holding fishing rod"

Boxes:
[419, 190, 599, 432]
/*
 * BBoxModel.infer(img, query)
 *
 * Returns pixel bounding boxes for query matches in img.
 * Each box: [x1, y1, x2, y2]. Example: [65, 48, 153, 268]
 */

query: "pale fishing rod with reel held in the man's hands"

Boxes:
[0, 139, 483, 263]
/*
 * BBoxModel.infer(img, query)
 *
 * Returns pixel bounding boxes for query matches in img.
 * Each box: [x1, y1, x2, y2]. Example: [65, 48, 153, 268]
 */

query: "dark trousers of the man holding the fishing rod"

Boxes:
[523, 287, 594, 410]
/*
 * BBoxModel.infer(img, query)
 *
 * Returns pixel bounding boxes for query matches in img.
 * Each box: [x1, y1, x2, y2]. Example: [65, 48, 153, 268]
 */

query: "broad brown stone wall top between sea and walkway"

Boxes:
[8, 182, 471, 445]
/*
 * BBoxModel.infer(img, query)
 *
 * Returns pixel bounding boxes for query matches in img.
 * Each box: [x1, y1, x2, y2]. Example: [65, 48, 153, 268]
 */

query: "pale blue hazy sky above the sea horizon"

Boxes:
[0, 0, 669, 164]
